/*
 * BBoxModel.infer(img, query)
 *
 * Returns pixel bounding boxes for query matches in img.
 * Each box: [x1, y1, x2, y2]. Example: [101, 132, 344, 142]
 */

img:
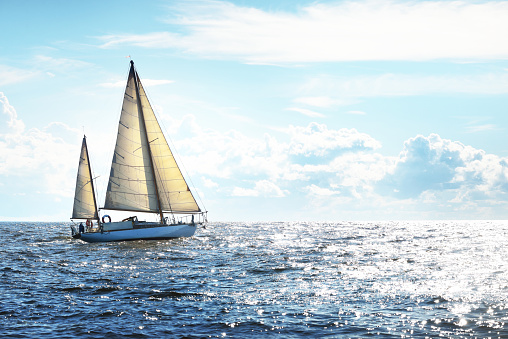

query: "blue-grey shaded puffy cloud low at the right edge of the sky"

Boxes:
[379, 134, 508, 202]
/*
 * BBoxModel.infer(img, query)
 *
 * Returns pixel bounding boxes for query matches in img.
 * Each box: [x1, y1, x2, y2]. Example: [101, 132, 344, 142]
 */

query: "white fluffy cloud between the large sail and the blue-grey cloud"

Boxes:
[170, 116, 381, 189]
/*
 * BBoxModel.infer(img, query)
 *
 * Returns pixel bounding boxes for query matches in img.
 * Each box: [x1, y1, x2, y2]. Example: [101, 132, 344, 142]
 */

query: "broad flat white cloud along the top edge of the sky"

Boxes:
[100, 0, 508, 64]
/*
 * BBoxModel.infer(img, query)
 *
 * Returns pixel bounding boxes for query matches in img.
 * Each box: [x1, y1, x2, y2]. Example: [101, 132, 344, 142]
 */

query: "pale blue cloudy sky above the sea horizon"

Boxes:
[0, 0, 508, 222]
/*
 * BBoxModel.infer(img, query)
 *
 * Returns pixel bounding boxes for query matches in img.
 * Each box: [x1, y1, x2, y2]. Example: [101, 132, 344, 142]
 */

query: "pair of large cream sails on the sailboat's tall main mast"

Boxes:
[104, 61, 201, 214]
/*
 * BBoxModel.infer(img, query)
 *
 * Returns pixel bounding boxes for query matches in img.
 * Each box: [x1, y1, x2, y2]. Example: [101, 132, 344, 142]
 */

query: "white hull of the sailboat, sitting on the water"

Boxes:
[77, 224, 197, 242]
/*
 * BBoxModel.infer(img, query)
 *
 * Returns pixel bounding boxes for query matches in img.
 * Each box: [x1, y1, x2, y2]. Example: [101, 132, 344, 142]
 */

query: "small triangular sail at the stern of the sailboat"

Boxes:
[71, 137, 98, 219]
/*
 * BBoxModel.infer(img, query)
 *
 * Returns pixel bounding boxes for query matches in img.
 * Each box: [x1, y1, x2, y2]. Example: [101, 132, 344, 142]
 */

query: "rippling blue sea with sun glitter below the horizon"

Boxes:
[0, 221, 508, 338]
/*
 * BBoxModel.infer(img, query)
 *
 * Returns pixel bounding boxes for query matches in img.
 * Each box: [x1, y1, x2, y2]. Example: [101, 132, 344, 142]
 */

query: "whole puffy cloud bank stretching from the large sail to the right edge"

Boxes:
[171, 115, 508, 218]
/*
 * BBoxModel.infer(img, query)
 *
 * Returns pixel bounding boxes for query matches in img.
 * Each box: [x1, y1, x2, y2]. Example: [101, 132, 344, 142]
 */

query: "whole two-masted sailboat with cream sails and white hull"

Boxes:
[71, 60, 207, 242]
